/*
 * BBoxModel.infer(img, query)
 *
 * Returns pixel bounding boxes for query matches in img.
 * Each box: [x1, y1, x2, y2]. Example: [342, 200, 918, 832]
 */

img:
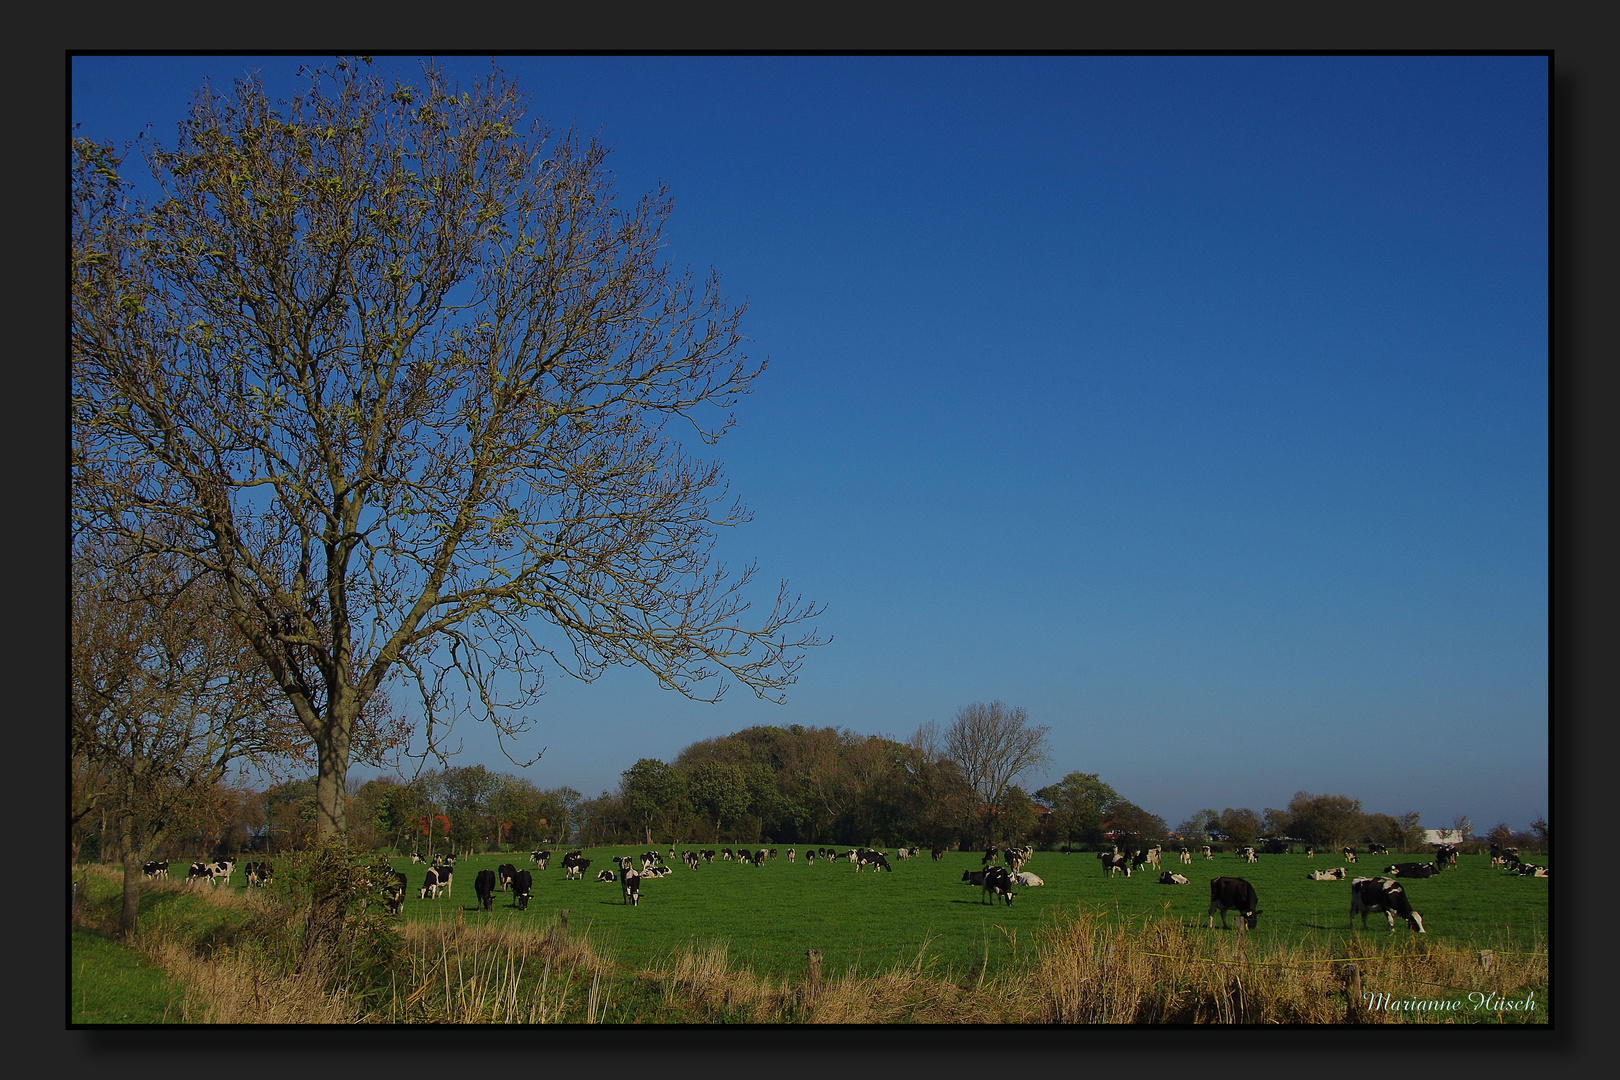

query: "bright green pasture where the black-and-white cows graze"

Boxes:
[364, 847, 1550, 976]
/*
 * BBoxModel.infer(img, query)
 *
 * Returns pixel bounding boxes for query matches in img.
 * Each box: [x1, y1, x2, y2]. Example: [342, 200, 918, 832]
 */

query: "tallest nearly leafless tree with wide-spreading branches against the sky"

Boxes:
[70, 60, 820, 837]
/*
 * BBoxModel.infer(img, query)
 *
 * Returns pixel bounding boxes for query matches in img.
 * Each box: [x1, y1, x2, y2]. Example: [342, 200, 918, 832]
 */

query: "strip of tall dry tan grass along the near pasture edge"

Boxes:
[76, 867, 1549, 1025]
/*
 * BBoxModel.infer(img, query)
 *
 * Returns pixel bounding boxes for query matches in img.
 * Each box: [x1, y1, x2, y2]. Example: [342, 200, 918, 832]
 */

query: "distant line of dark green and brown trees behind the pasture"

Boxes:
[72, 724, 1547, 858]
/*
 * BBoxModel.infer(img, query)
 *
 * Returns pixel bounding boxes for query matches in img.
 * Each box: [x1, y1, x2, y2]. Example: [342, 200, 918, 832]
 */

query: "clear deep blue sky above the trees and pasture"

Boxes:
[71, 57, 1550, 829]
